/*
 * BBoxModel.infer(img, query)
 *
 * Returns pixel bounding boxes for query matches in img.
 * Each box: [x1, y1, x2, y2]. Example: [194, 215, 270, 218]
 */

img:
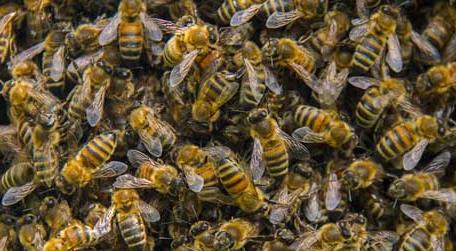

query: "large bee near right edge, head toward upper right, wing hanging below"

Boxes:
[376, 115, 446, 170]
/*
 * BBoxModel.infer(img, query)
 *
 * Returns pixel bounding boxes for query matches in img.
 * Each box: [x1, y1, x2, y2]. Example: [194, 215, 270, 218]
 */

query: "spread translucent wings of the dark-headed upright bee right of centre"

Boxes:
[250, 127, 310, 182]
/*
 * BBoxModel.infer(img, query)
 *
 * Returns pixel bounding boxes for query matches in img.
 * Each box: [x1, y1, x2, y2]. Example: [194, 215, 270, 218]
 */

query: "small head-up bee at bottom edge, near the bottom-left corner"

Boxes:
[18, 214, 47, 251]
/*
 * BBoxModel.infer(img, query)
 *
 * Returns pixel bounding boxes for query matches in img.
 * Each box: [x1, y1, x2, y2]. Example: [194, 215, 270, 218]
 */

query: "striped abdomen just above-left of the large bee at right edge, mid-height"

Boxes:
[355, 87, 386, 128]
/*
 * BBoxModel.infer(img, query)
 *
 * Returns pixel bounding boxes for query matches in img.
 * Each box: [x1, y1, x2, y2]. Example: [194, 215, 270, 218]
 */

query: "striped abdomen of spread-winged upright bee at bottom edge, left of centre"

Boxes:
[116, 212, 147, 251]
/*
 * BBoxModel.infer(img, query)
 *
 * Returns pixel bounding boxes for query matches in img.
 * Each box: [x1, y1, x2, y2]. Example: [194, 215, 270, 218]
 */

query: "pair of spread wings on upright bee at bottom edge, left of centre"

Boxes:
[93, 200, 160, 238]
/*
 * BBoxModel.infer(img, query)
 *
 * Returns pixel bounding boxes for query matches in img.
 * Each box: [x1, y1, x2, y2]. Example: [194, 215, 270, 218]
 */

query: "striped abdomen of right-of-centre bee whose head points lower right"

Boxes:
[294, 105, 331, 133]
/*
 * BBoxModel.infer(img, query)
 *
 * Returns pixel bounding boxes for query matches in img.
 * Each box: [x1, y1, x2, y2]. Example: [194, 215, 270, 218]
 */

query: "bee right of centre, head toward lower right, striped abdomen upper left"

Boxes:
[293, 105, 357, 155]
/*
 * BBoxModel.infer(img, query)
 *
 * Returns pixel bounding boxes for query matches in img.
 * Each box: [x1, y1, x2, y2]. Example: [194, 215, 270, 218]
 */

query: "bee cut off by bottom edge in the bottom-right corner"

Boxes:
[397, 204, 449, 251]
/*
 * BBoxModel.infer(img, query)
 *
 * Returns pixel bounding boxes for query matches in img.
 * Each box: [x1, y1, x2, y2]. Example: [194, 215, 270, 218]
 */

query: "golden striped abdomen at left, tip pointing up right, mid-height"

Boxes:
[76, 133, 117, 169]
